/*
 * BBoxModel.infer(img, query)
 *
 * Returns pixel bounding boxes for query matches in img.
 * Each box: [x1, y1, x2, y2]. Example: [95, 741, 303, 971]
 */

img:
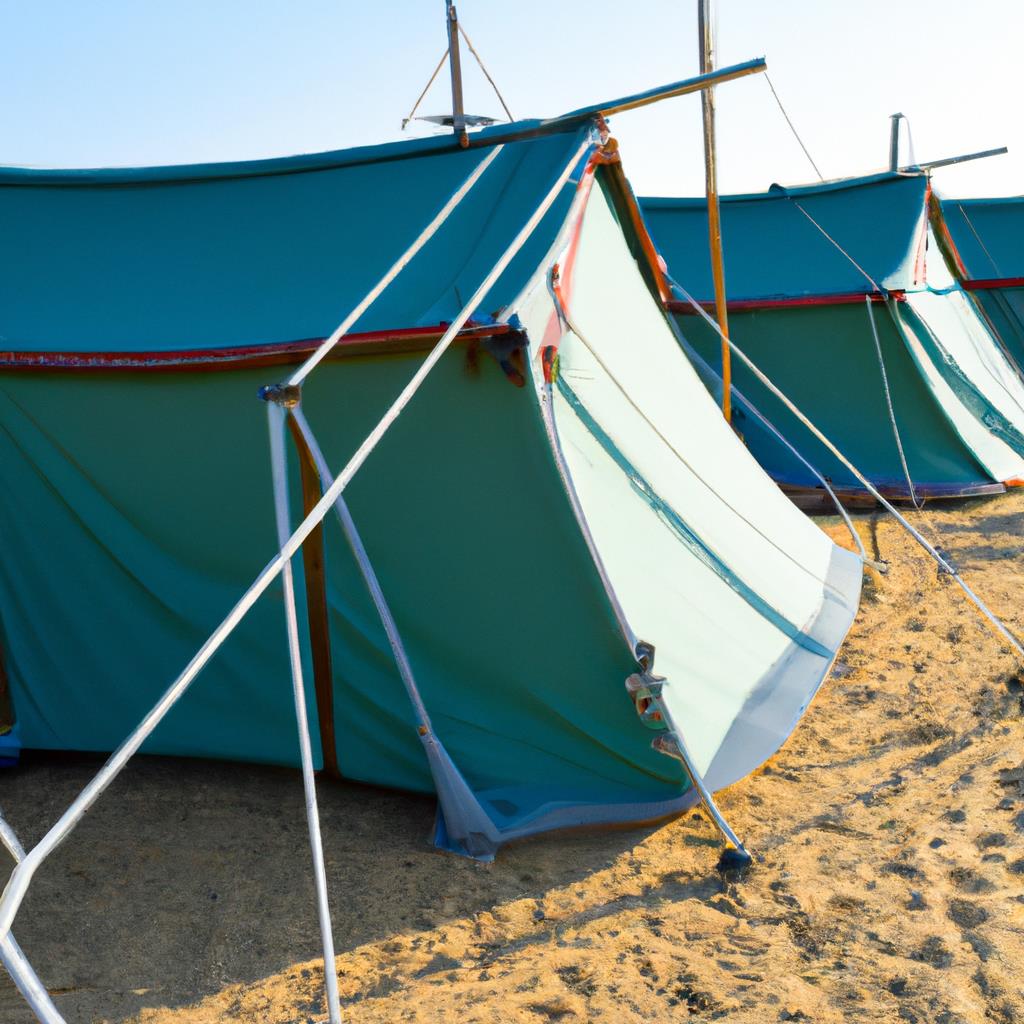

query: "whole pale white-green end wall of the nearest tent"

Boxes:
[520, 176, 860, 786]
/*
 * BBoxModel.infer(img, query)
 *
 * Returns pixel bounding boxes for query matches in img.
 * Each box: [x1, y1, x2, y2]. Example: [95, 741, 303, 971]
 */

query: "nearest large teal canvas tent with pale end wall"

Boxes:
[0, 61, 861, 1019]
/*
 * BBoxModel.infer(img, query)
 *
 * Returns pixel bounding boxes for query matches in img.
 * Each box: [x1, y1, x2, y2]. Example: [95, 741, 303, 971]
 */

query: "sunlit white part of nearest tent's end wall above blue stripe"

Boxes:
[561, 177, 856, 638]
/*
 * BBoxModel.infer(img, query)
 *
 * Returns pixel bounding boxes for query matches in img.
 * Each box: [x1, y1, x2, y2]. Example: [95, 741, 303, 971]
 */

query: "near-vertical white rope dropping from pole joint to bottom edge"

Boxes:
[266, 402, 341, 1024]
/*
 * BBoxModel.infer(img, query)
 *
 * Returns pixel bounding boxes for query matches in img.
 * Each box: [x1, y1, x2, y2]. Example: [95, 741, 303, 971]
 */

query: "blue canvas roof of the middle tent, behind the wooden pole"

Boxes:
[640, 173, 928, 300]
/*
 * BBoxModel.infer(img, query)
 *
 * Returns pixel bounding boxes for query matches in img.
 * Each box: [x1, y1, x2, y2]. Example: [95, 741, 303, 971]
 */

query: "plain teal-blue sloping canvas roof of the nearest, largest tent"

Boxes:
[0, 118, 591, 353]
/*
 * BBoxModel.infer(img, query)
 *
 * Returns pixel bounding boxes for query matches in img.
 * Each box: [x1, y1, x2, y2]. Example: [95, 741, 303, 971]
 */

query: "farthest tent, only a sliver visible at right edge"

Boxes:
[931, 196, 1024, 377]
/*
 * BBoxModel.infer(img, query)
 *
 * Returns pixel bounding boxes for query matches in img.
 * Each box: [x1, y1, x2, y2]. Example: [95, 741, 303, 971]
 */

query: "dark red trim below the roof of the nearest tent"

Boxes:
[0, 324, 512, 371]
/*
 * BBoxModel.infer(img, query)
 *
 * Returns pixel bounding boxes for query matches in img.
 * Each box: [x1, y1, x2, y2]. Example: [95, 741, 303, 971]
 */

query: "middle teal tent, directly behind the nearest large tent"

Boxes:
[641, 173, 1024, 506]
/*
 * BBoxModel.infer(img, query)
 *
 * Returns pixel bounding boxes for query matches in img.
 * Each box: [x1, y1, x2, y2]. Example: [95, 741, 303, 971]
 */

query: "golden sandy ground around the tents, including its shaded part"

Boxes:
[0, 493, 1024, 1024]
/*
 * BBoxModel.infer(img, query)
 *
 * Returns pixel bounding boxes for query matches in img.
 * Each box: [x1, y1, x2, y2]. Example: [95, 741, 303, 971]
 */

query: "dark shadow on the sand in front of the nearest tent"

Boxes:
[0, 754, 720, 1024]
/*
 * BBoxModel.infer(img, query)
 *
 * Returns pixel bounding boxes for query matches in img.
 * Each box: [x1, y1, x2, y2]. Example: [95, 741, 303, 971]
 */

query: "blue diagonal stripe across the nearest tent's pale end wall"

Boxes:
[558, 374, 835, 660]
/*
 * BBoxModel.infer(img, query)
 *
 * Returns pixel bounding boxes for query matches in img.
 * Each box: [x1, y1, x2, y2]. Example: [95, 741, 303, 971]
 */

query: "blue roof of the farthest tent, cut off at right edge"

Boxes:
[941, 196, 1024, 281]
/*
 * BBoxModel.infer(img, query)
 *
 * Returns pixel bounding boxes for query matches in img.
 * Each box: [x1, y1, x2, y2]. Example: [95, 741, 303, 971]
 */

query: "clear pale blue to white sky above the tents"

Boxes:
[0, 0, 1024, 196]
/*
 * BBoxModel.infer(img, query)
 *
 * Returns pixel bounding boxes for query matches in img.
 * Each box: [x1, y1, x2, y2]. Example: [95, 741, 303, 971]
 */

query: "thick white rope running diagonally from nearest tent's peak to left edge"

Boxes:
[0, 138, 591, 941]
